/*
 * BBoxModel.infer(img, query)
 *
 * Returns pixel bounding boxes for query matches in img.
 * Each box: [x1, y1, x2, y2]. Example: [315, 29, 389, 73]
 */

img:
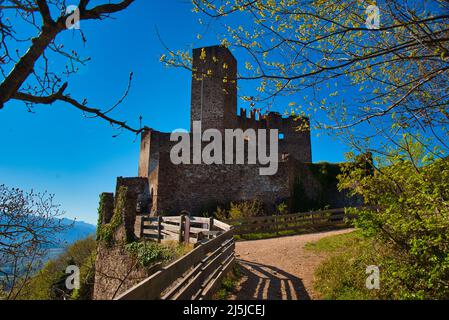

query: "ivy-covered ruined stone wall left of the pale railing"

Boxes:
[93, 178, 153, 300]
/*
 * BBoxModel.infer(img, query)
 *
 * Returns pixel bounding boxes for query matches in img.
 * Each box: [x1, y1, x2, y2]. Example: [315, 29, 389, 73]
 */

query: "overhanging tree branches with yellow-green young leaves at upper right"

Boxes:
[161, 0, 449, 155]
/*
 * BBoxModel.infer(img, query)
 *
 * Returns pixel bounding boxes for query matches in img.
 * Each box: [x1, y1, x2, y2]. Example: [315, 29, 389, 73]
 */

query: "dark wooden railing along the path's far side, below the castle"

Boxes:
[226, 209, 355, 235]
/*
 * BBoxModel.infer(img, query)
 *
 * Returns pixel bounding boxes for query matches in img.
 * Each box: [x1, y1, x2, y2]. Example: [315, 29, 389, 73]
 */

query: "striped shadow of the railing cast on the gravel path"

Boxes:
[235, 260, 310, 300]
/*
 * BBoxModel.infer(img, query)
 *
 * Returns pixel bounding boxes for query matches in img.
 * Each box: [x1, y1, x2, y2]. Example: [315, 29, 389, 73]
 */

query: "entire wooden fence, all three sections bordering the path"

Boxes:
[116, 209, 355, 300]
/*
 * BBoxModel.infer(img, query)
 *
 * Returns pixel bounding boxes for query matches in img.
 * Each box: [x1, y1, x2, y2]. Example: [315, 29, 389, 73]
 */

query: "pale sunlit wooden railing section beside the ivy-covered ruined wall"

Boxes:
[140, 215, 230, 244]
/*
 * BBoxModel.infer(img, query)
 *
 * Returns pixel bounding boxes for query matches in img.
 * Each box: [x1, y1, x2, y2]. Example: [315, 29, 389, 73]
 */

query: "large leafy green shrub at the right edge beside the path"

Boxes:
[340, 136, 449, 299]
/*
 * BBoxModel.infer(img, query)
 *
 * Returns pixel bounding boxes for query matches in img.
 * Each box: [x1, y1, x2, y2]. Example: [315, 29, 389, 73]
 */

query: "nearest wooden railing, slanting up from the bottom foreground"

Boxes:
[116, 228, 235, 300]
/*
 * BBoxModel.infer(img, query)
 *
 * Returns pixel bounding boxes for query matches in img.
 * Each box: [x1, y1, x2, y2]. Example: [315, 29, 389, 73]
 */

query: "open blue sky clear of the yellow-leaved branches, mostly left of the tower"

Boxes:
[0, 0, 347, 223]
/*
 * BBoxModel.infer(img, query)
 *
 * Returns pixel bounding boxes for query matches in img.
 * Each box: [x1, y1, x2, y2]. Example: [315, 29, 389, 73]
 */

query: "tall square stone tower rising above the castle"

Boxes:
[190, 46, 237, 132]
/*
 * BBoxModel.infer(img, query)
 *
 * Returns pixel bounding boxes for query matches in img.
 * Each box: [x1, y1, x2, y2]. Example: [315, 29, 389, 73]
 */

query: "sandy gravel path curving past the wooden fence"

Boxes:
[231, 229, 353, 300]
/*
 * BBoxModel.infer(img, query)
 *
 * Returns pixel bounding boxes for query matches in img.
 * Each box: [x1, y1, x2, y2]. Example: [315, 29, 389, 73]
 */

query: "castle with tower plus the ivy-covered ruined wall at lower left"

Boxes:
[93, 46, 354, 299]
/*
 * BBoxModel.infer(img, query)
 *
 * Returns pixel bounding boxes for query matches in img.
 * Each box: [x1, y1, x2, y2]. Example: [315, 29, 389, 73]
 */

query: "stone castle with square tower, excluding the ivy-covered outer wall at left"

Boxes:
[109, 46, 349, 219]
